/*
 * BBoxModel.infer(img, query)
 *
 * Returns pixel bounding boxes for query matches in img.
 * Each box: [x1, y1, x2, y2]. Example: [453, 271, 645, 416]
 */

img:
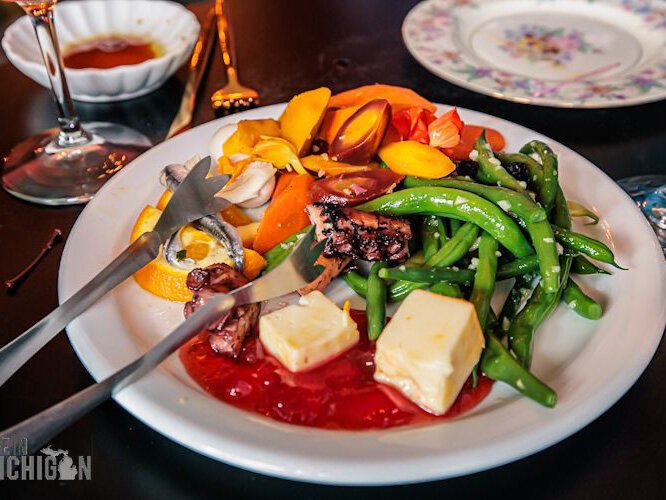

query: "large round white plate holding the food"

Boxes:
[59, 105, 666, 484]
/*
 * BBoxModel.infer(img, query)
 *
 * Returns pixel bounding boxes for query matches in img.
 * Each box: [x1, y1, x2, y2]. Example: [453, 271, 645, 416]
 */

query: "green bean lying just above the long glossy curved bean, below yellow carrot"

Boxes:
[403, 177, 546, 222]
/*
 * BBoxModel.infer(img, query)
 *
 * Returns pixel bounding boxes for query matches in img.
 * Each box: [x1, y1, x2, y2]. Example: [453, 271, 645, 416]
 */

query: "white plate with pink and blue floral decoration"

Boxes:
[402, 0, 666, 108]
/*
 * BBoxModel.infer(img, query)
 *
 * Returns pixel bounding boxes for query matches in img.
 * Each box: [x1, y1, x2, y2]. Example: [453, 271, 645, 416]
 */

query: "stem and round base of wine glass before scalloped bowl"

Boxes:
[2, 0, 151, 205]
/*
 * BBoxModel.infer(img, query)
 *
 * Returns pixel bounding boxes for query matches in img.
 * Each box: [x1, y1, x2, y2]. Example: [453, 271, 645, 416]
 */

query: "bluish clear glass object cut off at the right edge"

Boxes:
[618, 175, 666, 257]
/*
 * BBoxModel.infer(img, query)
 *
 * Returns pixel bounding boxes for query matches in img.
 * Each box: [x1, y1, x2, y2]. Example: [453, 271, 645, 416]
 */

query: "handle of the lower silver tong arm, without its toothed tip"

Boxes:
[0, 294, 236, 454]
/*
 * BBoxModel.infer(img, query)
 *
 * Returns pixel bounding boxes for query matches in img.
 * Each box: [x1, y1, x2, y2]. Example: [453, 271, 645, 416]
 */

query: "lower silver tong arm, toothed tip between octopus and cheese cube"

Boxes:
[0, 230, 323, 454]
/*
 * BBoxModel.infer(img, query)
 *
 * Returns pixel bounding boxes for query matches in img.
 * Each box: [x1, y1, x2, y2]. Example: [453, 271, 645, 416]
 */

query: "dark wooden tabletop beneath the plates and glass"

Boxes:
[0, 0, 666, 499]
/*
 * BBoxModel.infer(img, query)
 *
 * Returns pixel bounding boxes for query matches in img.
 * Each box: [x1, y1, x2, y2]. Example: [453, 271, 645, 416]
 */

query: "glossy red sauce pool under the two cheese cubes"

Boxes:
[180, 310, 492, 430]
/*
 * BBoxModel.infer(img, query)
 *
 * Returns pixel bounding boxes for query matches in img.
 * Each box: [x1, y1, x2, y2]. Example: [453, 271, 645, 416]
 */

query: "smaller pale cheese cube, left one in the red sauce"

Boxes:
[259, 292, 359, 372]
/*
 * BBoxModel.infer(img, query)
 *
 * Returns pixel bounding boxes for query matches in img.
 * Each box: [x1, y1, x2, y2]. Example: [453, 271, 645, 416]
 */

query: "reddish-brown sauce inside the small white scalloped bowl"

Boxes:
[63, 35, 162, 69]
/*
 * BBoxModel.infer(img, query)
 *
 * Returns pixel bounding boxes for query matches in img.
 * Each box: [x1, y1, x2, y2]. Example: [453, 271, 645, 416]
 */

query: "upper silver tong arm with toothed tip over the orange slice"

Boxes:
[0, 157, 229, 385]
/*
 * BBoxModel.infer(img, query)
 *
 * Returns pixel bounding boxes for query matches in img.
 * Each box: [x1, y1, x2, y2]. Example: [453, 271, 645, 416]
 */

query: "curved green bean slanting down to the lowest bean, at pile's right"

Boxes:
[509, 256, 572, 368]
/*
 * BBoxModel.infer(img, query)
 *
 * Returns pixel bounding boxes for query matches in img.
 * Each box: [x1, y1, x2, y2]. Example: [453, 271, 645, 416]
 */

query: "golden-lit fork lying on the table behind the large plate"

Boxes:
[210, 0, 259, 112]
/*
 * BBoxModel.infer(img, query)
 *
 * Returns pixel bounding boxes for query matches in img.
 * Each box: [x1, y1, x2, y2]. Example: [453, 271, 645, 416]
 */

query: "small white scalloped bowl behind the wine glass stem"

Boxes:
[2, 0, 200, 102]
